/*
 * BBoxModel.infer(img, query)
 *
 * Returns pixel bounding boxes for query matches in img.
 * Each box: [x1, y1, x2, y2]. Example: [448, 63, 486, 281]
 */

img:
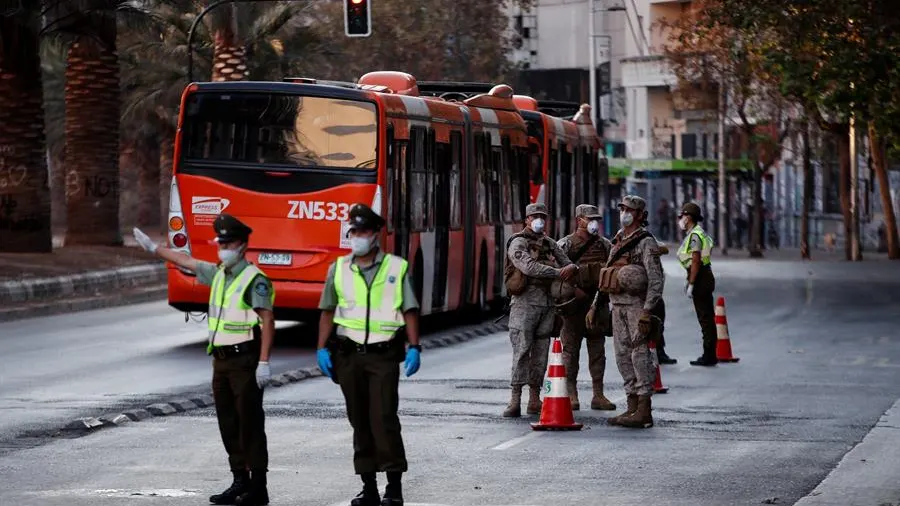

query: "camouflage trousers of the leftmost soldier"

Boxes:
[509, 304, 556, 388]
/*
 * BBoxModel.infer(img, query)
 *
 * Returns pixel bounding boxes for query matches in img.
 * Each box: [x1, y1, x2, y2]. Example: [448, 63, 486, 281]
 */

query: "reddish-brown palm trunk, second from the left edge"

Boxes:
[65, 31, 122, 245]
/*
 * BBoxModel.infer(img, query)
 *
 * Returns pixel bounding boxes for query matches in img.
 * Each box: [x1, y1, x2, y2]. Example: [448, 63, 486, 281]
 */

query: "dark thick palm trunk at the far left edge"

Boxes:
[0, 16, 53, 253]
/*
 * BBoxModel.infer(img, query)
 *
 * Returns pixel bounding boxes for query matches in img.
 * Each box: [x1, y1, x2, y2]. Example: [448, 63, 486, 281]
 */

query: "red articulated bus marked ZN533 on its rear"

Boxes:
[168, 72, 529, 321]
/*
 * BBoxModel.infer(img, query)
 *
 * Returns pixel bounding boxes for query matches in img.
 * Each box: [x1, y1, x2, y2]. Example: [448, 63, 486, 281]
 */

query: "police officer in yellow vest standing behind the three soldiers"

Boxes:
[678, 202, 718, 366]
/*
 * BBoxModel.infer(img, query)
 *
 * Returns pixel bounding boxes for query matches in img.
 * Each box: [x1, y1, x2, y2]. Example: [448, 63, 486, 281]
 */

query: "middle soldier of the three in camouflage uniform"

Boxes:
[557, 204, 616, 410]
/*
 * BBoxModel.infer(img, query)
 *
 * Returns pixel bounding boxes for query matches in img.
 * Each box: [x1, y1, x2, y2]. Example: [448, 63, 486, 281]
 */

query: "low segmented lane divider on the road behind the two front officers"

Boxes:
[62, 321, 508, 435]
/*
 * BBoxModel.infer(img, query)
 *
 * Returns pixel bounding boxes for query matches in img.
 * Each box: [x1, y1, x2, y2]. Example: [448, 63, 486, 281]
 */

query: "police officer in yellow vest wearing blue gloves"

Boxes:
[317, 204, 422, 506]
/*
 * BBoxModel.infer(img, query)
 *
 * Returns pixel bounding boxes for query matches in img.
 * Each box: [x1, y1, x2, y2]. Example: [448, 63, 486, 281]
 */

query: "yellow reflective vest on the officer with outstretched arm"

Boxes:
[207, 264, 275, 351]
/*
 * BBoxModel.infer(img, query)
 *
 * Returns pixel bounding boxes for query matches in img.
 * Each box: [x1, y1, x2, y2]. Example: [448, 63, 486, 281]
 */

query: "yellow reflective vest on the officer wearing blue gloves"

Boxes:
[333, 253, 409, 344]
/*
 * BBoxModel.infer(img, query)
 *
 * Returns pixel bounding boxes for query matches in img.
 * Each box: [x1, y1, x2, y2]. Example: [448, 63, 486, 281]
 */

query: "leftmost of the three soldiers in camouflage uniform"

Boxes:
[503, 204, 578, 417]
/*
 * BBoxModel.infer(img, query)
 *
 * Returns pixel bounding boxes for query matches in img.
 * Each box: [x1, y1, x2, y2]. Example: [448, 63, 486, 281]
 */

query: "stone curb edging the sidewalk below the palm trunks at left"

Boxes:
[0, 263, 168, 305]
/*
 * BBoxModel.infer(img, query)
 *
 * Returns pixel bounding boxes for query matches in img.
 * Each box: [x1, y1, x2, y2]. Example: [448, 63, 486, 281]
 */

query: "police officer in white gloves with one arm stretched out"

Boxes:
[134, 214, 275, 506]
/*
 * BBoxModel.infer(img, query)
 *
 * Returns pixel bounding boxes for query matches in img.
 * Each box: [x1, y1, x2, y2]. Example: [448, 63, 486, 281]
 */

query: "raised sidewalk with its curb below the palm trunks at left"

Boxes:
[0, 228, 168, 321]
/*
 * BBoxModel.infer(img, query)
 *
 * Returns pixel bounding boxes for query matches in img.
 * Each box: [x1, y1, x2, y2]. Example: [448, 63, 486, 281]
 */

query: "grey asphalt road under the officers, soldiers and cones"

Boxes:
[0, 260, 900, 506]
